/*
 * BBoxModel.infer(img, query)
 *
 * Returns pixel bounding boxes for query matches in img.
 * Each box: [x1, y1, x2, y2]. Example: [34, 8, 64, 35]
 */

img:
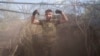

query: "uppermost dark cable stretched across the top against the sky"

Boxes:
[0, 1, 100, 6]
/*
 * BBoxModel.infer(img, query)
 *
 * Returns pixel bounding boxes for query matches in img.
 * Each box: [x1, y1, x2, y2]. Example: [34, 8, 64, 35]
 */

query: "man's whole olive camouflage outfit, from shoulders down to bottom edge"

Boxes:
[40, 19, 59, 56]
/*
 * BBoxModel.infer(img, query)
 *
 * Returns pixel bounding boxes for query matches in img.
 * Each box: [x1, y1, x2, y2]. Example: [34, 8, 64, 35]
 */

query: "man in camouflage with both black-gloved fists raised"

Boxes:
[31, 9, 68, 56]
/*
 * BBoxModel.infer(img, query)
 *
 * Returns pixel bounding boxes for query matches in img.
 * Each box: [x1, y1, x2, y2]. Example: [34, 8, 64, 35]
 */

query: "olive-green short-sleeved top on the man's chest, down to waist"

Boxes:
[40, 19, 60, 36]
